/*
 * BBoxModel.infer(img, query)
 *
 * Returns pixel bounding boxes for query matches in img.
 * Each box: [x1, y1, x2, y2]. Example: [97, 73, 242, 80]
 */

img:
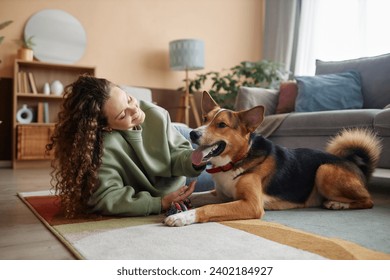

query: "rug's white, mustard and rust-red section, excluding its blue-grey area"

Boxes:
[18, 191, 390, 260]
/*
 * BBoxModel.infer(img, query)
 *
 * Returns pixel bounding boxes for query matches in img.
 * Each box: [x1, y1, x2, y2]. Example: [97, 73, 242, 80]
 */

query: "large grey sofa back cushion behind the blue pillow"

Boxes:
[316, 54, 390, 109]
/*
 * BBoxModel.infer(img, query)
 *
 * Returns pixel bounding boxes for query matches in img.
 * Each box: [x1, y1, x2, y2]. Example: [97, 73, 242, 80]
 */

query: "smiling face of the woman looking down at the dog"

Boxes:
[103, 86, 145, 130]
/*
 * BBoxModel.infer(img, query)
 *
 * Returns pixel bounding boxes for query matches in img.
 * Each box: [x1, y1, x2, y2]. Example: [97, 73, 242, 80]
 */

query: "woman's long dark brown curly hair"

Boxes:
[46, 75, 114, 218]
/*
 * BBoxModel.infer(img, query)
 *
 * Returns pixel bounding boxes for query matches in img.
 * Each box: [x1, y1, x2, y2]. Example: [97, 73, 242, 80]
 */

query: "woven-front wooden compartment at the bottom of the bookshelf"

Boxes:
[16, 125, 54, 160]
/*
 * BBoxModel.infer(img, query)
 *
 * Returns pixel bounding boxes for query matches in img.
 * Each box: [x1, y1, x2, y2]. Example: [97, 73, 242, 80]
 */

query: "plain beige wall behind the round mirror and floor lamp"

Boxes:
[0, 0, 264, 88]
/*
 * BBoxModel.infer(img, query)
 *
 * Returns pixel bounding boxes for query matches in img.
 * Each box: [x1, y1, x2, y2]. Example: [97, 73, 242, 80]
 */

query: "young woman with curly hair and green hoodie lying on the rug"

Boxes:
[47, 76, 210, 217]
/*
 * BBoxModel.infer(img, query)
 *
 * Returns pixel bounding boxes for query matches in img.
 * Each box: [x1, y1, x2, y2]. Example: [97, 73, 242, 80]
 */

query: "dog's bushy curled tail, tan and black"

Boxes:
[326, 129, 382, 180]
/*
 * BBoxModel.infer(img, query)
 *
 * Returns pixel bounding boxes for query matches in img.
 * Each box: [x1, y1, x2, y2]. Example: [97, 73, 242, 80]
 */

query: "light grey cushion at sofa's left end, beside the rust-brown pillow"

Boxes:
[234, 87, 279, 116]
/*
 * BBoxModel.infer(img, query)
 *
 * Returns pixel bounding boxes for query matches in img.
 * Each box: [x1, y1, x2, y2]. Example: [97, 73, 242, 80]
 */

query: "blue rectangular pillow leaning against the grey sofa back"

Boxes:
[295, 71, 363, 112]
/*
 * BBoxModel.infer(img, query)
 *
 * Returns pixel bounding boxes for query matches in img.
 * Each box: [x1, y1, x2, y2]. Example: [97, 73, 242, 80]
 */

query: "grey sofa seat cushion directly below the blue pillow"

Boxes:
[272, 109, 383, 137]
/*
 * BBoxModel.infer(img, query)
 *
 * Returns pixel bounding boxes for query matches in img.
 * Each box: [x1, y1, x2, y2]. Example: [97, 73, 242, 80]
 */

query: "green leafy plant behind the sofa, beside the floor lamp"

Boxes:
[189, 60, 287, 109]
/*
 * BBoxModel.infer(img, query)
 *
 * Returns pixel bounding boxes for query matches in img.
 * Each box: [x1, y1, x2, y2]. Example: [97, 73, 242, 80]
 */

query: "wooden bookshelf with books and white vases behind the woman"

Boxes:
[12, 59, 95, 168]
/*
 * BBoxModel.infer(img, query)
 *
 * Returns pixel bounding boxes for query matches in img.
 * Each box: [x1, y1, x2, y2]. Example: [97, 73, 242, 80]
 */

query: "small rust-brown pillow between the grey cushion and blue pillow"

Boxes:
[276, 81, 298, 114]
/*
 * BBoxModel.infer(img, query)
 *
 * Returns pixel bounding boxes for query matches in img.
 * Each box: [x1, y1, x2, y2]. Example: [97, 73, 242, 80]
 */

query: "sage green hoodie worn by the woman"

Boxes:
[89, 101, 202, 216]
